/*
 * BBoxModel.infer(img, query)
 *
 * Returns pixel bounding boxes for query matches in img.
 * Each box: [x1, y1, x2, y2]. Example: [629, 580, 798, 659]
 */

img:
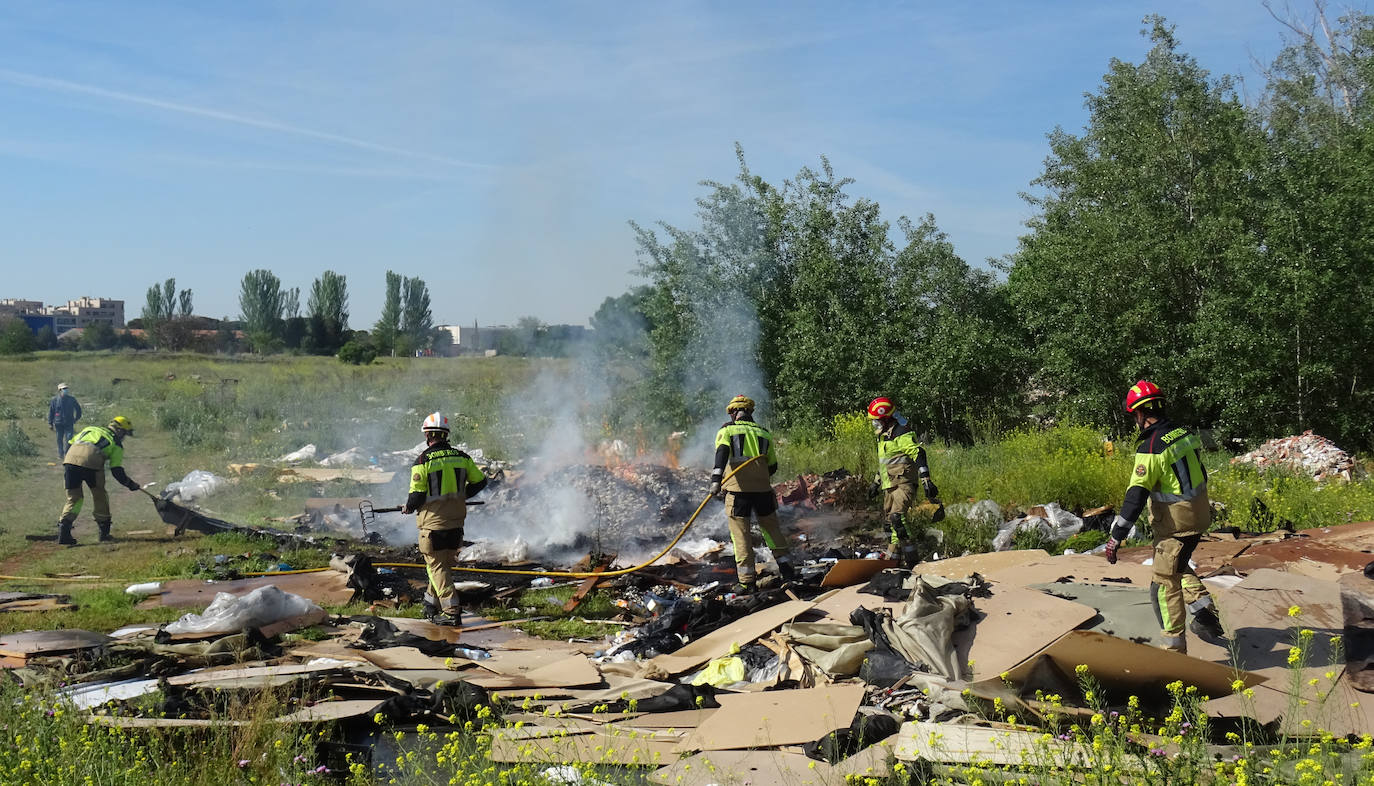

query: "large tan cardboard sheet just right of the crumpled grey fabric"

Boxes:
[954, 584, 1098, 680]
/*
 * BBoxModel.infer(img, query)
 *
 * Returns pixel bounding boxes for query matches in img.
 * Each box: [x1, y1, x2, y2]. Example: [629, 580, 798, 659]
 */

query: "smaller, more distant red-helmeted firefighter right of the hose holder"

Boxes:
[868, 396, 940, 568]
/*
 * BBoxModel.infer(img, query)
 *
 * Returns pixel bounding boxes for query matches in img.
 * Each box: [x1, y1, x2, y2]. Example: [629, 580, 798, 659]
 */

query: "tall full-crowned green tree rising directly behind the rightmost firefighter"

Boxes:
[1009, 18, 1264, 434]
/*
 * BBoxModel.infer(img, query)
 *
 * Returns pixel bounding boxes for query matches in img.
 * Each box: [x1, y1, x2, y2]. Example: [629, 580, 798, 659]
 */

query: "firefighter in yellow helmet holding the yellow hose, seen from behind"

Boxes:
[710, 396, 797, 592]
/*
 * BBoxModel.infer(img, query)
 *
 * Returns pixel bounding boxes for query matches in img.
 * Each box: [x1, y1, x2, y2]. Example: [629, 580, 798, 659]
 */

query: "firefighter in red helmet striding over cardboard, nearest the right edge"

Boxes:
[1106, 379, 1226, 653]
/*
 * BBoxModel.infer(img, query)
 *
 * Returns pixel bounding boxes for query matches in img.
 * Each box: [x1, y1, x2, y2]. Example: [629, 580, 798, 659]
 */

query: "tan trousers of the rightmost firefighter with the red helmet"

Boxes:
[1150, 492, 1212, 653]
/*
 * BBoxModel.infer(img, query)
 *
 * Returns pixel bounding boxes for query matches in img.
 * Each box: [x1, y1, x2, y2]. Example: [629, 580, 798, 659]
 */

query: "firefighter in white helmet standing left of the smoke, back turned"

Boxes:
[401, 412, 486, 625]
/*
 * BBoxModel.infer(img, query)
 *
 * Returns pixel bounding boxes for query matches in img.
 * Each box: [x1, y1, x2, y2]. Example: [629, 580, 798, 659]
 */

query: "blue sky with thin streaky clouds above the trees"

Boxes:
[0, 0, 1308, 327]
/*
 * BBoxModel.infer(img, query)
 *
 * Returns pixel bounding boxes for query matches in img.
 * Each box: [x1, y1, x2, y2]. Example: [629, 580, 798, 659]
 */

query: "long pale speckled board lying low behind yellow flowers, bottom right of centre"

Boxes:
[894, 721, 1092, 767]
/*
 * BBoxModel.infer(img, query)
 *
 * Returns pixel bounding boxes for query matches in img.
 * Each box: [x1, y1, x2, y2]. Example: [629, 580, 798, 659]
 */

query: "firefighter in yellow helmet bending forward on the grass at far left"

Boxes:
[58, 415, 139, 546]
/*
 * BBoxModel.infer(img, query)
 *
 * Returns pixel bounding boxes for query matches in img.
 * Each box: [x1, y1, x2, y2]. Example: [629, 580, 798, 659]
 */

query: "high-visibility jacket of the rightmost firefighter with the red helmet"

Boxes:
[1121, 420, 1206, 524]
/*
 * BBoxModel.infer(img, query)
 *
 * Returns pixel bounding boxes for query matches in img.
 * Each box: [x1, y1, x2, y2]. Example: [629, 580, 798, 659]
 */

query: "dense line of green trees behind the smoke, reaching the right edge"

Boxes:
[592, 12, 1374, 448]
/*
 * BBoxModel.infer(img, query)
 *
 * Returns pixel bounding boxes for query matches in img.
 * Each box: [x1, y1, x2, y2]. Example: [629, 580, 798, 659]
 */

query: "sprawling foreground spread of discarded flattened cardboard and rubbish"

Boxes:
[0, 522, 1374, 786]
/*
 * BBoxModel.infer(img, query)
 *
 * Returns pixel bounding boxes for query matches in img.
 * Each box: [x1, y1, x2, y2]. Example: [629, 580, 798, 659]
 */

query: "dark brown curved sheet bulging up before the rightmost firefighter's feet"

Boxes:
[982, 631, 1265, 697]
